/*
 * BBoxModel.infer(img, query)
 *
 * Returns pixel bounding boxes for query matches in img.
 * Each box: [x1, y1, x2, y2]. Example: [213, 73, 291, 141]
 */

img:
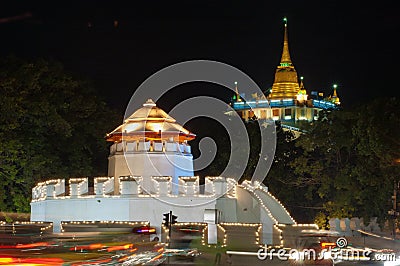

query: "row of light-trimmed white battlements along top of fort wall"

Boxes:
[32, 176, 237, 201]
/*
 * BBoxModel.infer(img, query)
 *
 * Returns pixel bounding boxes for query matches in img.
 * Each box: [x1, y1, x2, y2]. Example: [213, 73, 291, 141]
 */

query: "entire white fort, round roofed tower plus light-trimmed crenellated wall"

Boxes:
[31, 99, 316, 246]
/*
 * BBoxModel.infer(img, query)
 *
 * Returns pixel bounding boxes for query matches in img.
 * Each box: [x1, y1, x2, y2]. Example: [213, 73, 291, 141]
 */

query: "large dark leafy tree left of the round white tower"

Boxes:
[0, 57, 117, 212]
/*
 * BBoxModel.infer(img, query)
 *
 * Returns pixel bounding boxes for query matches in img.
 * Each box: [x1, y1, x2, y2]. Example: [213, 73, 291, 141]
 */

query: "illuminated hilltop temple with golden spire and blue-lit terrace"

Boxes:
[231, 18, 340, 131]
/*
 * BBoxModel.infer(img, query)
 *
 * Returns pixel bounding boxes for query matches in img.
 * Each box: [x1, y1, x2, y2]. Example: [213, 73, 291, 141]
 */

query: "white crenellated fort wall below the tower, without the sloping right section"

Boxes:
[31, 176, 234, 234]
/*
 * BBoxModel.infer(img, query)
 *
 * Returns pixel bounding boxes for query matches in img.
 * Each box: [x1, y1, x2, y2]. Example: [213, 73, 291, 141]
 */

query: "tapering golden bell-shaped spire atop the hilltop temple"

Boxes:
[268, 18, 300, 100]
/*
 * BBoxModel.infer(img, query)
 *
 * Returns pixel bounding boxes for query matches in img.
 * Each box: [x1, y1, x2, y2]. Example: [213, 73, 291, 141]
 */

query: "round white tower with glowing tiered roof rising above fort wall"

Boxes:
[107, 99, 195, 194]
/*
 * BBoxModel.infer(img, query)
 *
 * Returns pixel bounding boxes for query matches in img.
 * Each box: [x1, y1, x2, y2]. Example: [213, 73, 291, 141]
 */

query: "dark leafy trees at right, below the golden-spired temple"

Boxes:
[266, 98, 400, 220]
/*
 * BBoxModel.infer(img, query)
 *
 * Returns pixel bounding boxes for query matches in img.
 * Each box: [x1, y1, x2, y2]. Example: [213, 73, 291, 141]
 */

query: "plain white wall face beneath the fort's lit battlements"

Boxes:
[31, 196, 216, 234]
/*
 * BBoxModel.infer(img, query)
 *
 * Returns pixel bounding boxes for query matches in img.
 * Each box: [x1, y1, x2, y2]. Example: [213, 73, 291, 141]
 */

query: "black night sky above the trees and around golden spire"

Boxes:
[0, 0, 400, 110]
